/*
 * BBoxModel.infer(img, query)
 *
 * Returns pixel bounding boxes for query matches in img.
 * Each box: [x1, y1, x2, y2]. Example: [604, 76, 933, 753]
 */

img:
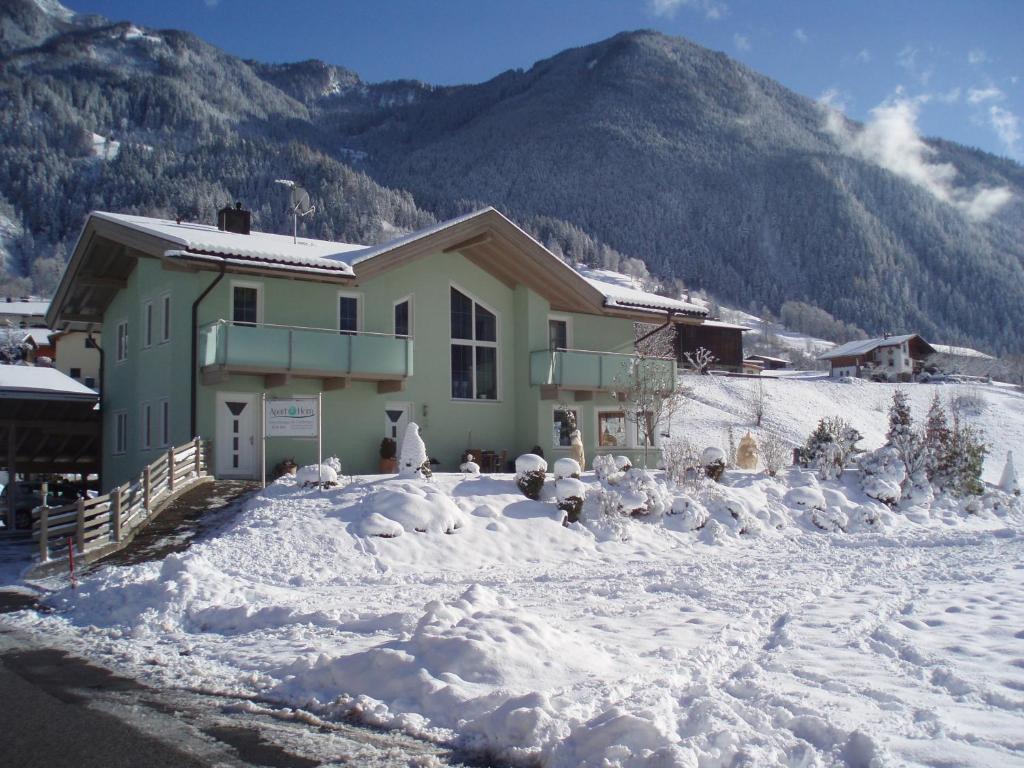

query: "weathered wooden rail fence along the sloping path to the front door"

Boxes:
[32, 437, 212, 563]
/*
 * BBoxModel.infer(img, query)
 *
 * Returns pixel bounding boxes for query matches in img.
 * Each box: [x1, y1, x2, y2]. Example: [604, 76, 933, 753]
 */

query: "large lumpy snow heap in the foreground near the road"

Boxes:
[275, 585, 612, 729]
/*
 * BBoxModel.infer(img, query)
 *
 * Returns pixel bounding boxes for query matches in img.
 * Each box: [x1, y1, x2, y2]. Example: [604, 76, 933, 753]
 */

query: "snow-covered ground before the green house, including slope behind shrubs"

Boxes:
[12, 377, 1024, 768]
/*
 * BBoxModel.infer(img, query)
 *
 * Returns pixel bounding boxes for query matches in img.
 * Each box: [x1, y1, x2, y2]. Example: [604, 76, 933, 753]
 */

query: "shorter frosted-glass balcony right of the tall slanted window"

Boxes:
[529, 349, 676, 400]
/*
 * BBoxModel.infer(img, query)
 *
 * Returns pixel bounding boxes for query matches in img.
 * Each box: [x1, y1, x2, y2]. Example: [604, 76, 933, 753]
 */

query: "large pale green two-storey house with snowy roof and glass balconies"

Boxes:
[47, 208, 703, 487]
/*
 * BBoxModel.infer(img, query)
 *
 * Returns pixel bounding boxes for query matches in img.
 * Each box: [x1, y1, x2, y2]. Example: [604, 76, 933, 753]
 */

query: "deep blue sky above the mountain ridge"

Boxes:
[67, 0, 1024, 161]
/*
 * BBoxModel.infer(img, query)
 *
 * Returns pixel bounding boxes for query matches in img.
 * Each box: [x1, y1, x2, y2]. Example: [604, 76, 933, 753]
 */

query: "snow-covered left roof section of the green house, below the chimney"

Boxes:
[92, 211, 366, 275]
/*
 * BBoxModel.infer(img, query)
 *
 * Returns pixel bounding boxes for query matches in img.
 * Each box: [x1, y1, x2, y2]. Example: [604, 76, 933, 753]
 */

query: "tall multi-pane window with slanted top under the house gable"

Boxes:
[452, 288, 498, 400]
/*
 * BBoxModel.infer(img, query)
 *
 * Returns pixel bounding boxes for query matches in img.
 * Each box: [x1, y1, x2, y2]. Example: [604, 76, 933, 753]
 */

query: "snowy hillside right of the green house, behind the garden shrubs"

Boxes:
[672, 372, 1024, 482]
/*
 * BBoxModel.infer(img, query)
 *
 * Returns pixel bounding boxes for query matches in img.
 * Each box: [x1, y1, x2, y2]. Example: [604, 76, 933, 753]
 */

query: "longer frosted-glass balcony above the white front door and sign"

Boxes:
[199, 319, 413, 392]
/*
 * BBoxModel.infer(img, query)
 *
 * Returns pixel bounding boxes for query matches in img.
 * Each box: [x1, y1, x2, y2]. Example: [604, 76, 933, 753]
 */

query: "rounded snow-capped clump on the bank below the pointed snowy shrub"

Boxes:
[352, 483, 467, 538]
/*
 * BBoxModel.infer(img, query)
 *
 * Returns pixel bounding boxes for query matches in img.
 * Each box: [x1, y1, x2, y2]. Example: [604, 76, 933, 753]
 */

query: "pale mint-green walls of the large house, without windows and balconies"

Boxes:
[103, 246, 659, 487]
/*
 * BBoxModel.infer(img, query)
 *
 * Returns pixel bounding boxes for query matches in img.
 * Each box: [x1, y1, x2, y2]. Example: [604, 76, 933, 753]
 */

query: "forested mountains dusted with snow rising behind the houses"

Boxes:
[0, 0, 1024, 352]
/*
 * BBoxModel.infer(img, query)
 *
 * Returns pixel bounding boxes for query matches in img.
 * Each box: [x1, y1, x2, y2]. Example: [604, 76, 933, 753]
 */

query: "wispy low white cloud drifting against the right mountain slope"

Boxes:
[819, 96, 1019, 221]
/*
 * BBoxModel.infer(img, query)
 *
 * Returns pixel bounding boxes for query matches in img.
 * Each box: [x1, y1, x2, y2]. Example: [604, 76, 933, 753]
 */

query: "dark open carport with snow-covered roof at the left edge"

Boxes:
[0, 366, 101, 531]
